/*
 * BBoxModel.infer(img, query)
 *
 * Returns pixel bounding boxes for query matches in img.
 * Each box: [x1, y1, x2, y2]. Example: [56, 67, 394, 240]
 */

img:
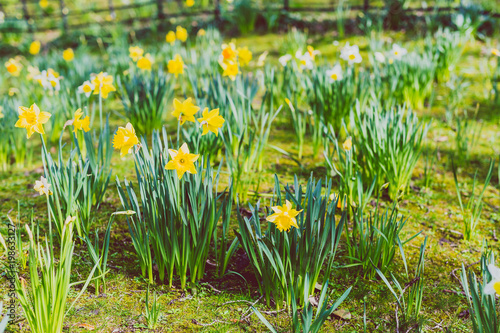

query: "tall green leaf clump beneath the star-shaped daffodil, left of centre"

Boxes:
[117, 129, 231, 289]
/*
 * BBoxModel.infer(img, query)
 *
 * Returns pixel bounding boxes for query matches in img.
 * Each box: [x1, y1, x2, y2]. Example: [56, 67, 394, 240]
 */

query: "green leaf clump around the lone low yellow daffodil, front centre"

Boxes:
[236, 176, 345, 308]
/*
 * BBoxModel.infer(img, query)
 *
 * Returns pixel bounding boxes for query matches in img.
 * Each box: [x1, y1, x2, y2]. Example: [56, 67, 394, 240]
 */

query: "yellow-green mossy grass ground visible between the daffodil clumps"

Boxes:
[0, 27, 500, 332]
